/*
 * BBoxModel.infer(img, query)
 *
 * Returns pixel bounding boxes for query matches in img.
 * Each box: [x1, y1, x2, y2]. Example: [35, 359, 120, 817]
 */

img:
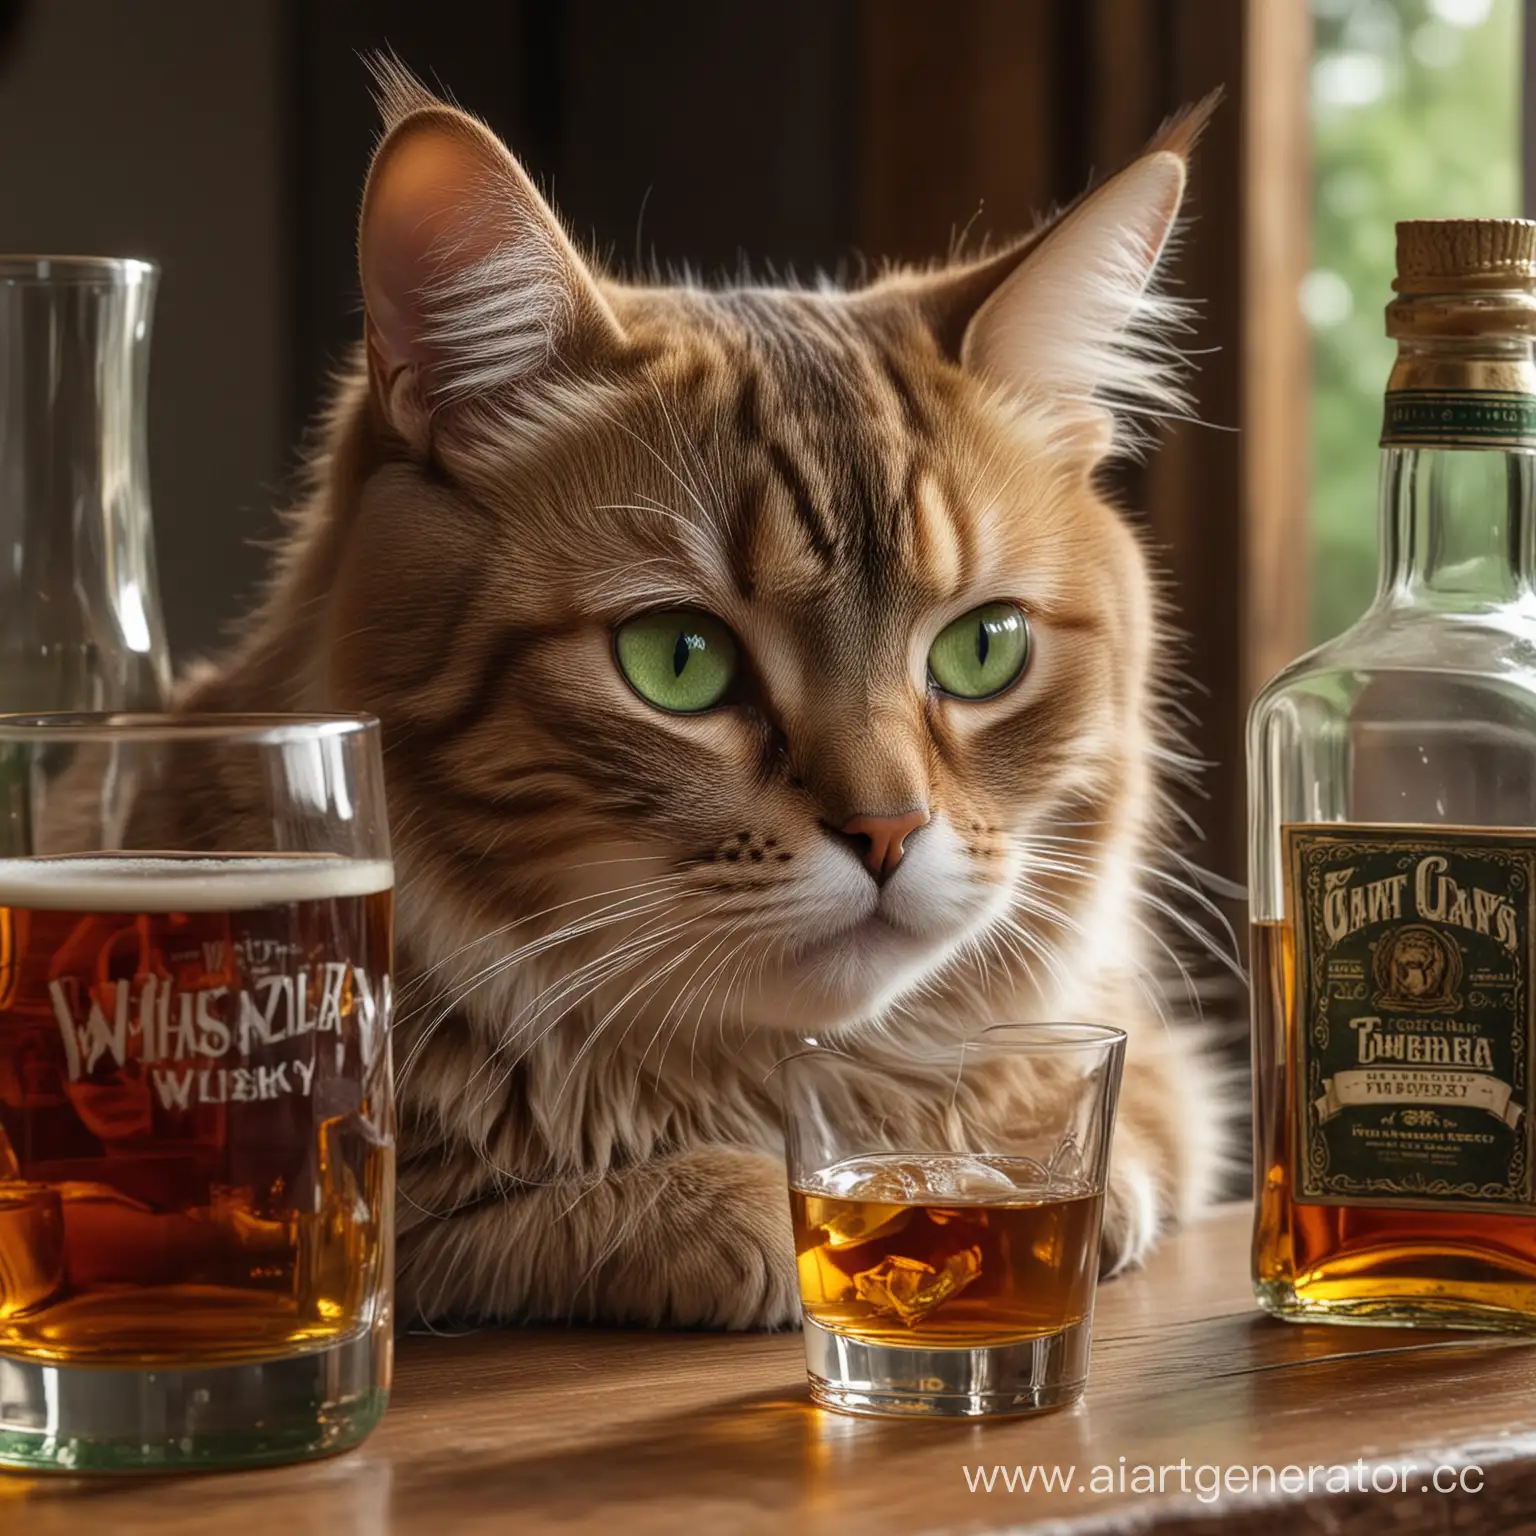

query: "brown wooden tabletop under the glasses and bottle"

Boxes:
[9, 1206, 1536, 1536]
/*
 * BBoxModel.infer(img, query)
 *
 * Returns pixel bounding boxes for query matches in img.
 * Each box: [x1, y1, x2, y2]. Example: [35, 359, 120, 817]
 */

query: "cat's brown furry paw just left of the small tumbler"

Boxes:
[601, 1147, 800, 1329]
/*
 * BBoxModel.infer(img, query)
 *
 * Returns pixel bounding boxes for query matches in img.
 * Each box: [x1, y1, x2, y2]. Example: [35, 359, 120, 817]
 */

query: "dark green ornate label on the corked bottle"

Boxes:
[1284, 825, 1536, 1212]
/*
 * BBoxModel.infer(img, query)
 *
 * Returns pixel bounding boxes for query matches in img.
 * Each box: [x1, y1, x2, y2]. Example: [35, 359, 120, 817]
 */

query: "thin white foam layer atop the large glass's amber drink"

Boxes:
[0, 854, 395, 912]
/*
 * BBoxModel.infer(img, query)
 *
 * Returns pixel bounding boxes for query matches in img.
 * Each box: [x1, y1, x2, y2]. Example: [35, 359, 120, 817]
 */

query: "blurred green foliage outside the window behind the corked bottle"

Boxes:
[1301, 0, 1521, 641]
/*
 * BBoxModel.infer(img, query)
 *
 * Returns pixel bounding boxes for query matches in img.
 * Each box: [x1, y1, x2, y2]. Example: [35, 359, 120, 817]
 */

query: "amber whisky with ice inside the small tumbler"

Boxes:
[790, 1157, 1103, 1349]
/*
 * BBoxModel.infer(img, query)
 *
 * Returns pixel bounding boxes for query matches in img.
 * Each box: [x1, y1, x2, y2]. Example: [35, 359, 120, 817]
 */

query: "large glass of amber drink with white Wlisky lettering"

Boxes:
[0, 714, 395, 1471]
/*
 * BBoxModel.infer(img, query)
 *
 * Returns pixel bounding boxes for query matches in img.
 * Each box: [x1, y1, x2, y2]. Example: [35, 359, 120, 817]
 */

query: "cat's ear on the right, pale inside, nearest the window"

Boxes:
[903, 94, 1220, 458]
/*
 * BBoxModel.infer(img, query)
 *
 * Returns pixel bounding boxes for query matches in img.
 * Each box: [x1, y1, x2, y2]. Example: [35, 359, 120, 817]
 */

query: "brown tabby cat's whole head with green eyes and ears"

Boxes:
[332, 66, 1201, 1032]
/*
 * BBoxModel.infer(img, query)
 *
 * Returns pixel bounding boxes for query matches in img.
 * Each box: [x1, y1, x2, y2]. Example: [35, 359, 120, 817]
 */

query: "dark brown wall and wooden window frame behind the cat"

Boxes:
[0, 0, 1309, 897]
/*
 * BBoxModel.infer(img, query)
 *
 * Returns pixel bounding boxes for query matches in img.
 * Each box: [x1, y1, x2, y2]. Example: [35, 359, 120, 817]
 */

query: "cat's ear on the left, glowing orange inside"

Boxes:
[358, 61, 622, 455]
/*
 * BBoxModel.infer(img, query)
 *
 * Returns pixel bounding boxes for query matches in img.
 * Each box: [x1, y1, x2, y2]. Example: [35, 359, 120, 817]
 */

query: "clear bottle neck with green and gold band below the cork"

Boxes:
[1378, 327, 1536, 610]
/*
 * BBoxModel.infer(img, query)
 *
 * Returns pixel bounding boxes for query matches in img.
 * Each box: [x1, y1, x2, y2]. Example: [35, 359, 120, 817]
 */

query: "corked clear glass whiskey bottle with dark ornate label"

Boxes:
[1247, 220, 1536, 1332]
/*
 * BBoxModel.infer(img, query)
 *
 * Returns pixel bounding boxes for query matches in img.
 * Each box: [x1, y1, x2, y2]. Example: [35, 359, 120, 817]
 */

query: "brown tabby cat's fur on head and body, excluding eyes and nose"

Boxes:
[186, 68, 1220, 1327]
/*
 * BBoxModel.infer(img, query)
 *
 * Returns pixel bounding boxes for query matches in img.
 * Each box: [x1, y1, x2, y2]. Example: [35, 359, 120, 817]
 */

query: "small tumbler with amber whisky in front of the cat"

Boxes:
[777, 1025, 1126, 1418]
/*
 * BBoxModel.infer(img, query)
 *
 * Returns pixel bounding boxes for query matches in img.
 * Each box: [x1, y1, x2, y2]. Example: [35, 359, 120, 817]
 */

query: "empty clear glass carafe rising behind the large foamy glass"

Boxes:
[0, 257, 170, 710]
